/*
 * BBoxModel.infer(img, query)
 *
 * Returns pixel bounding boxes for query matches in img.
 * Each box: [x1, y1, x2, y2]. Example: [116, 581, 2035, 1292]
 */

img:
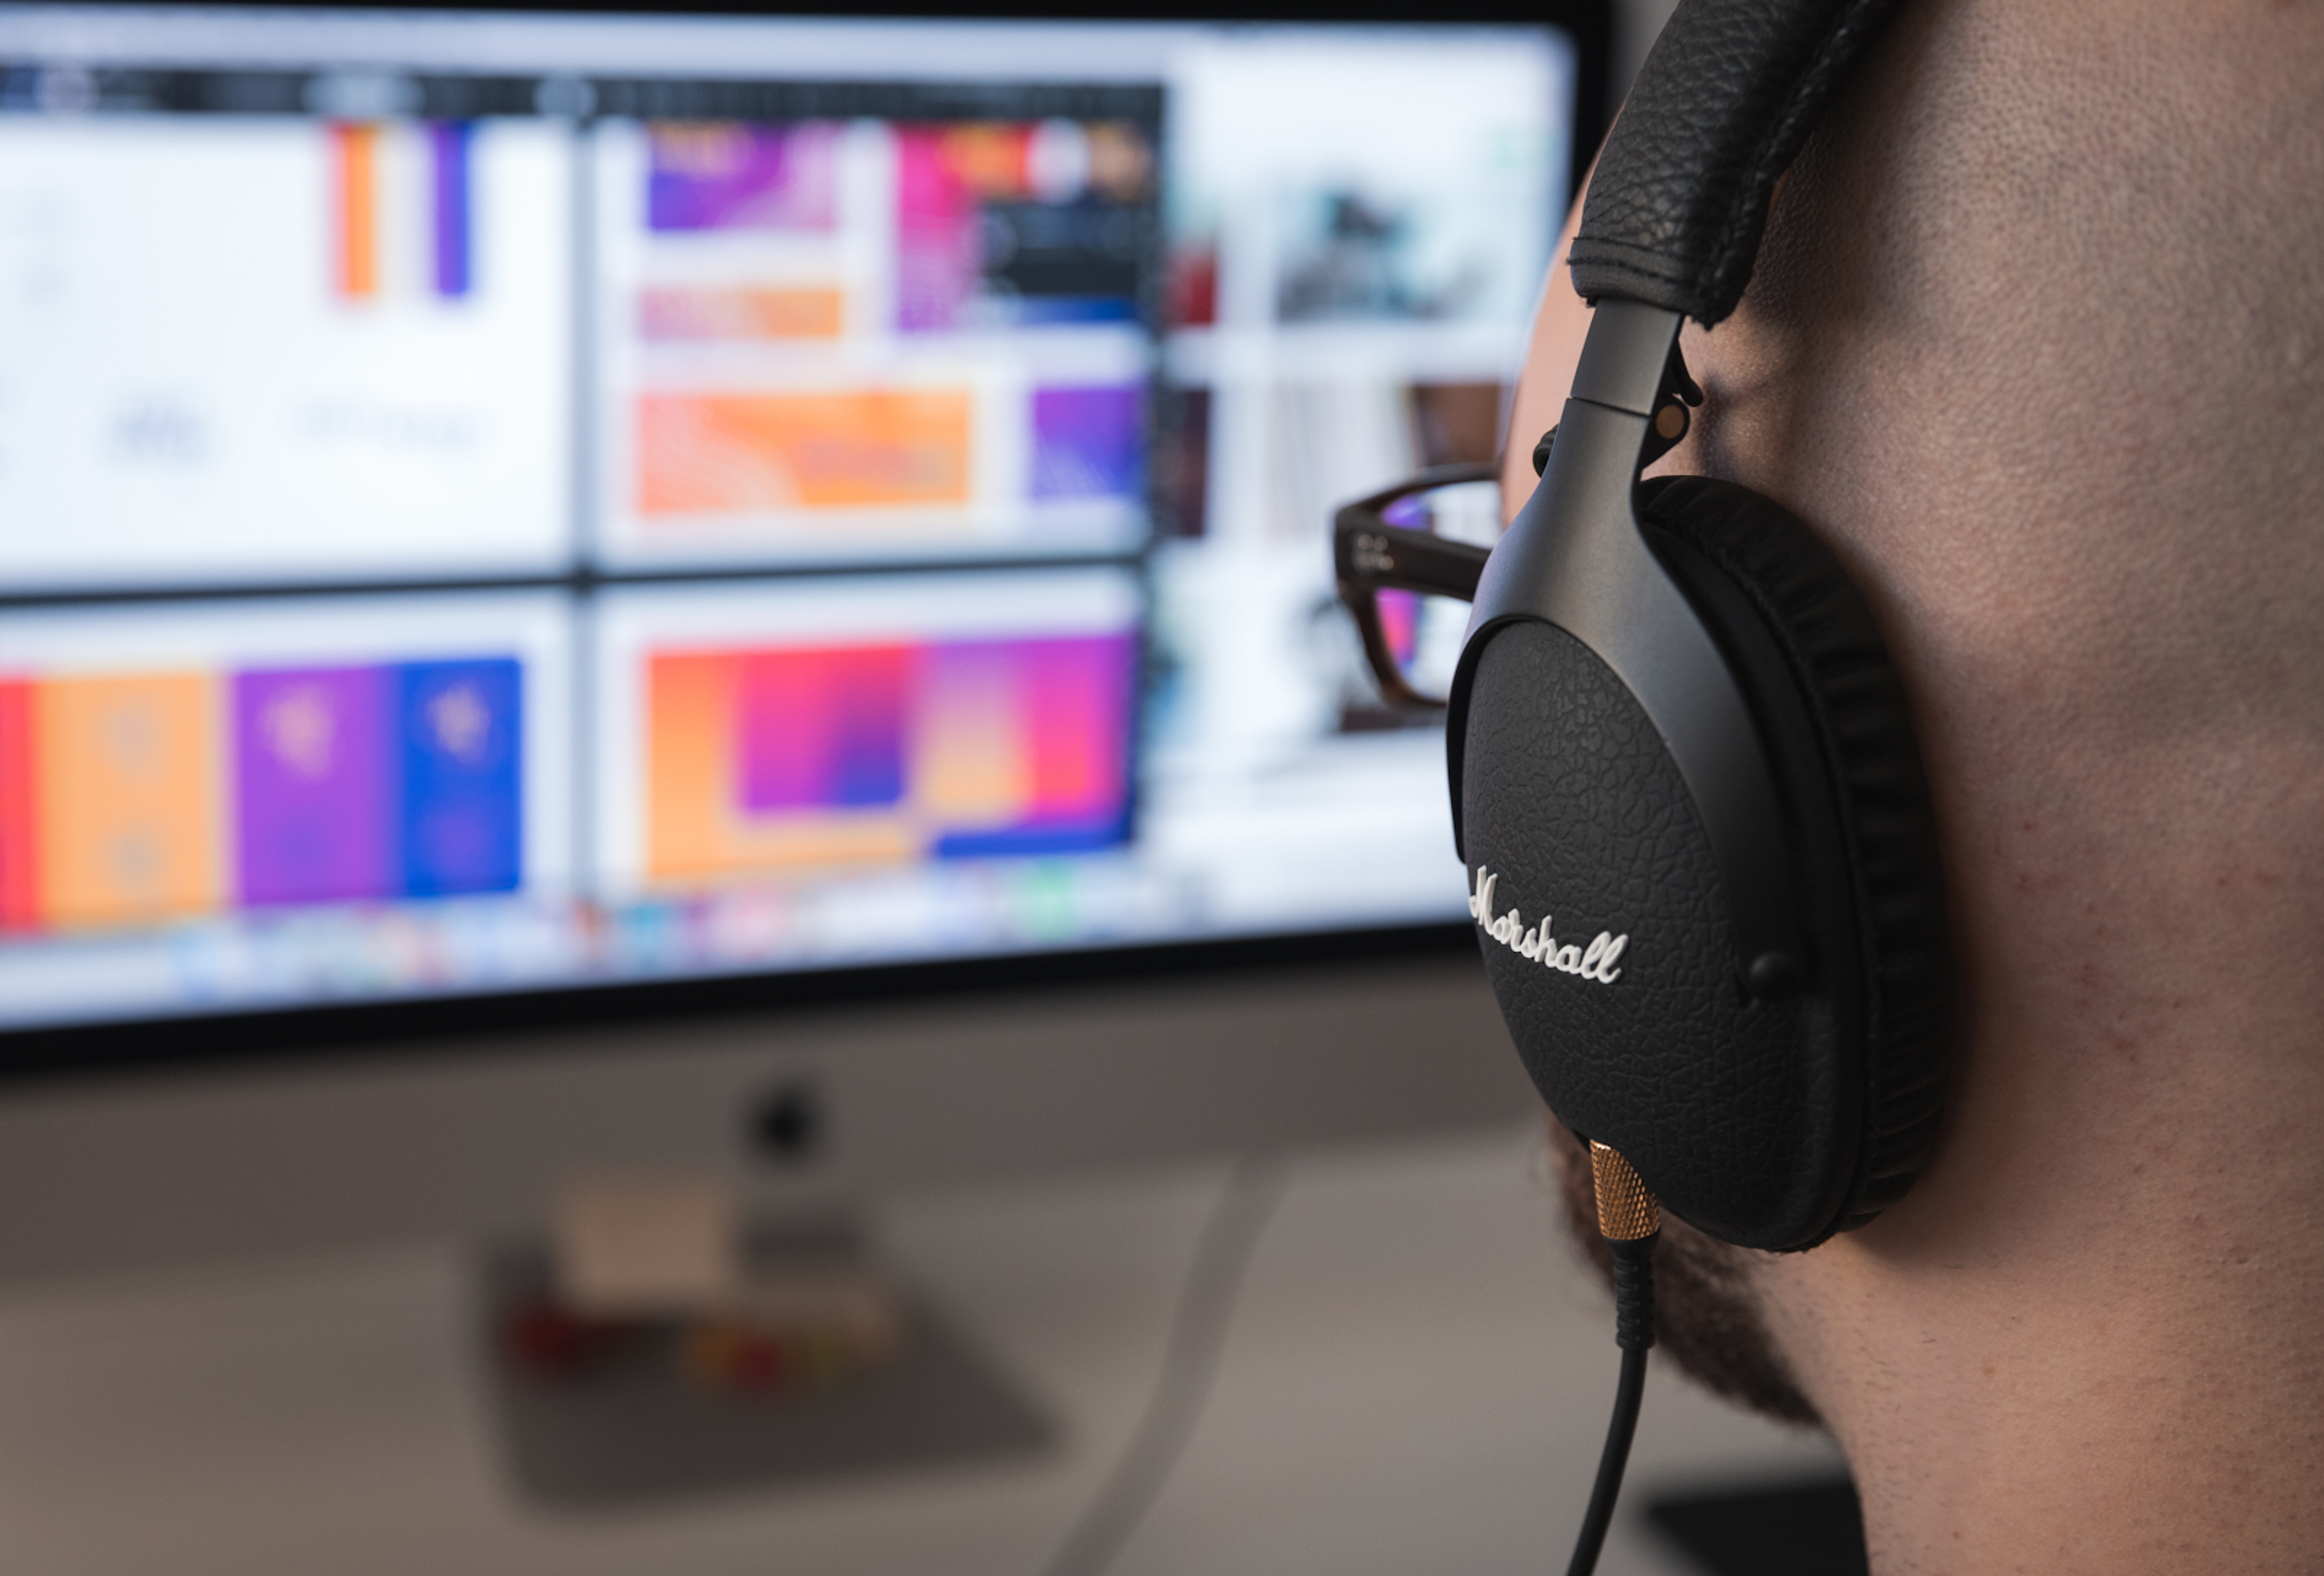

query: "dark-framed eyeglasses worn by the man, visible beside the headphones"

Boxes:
[1331, 465, 1502, 707]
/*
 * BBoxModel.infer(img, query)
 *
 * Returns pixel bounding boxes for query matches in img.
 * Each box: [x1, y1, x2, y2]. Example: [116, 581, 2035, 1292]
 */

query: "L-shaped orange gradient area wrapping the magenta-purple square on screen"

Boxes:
[646, 651, 922, 883]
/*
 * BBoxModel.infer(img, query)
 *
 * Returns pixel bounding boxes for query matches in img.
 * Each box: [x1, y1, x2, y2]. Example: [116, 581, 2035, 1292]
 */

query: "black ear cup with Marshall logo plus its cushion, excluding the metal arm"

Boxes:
[1457, 479, 1950, 1250]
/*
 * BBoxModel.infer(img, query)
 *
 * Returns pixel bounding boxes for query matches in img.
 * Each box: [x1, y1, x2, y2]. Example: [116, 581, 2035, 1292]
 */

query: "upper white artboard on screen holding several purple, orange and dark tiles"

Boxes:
[595, 119, 1155, 560]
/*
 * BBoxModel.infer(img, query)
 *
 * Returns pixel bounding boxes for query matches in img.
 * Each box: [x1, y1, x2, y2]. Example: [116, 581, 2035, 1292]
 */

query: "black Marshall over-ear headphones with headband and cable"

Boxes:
[1445, 0, 1952, 1571]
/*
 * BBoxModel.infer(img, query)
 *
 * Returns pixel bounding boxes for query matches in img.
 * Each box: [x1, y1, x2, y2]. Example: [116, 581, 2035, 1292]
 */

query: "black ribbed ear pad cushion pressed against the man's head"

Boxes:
[1638, 476, 1952, 1230]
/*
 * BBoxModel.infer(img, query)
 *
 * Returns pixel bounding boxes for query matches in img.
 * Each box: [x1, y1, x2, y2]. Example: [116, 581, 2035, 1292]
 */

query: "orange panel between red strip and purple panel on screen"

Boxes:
[28, 674, 223, 930]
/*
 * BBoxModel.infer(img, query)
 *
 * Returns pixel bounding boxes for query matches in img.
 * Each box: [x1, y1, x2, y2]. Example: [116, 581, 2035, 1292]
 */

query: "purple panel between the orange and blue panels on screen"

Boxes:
[232, 667, 399, 907]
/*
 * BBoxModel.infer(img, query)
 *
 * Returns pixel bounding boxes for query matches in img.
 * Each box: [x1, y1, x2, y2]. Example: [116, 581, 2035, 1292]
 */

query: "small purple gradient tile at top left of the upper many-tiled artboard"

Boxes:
[646, 121, 839, 232]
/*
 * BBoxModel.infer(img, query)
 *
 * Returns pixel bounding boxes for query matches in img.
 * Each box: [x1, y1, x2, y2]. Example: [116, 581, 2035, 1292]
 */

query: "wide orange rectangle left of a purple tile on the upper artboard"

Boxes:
[637, 388, 969, 516]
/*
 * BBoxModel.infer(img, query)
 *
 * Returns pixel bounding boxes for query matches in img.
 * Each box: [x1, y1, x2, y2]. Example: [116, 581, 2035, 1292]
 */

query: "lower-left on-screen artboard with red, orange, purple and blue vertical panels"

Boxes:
[0, 597, 567, 932]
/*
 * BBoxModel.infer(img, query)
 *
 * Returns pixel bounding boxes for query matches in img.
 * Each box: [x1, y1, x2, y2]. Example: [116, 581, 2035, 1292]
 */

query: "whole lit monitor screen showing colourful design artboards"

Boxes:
[0, 7, 1580, 1029]
